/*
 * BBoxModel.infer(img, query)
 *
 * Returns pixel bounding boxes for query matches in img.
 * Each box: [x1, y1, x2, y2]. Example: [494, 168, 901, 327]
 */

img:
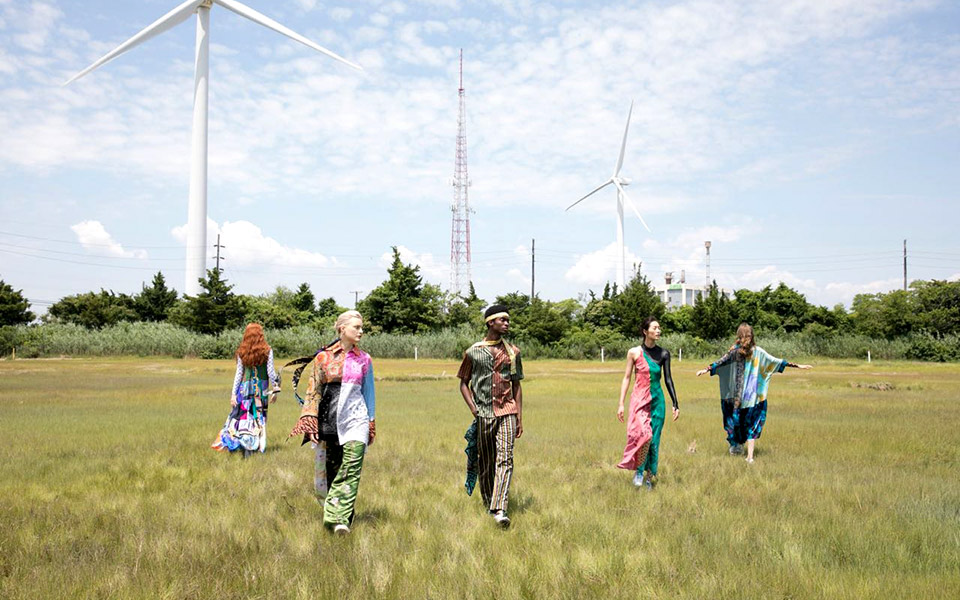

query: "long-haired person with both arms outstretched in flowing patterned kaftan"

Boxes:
[697, 323, 813, 463]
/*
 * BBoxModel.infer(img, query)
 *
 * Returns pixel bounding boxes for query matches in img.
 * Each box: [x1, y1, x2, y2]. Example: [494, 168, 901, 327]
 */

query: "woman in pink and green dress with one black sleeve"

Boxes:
[617, 317, 680, 490]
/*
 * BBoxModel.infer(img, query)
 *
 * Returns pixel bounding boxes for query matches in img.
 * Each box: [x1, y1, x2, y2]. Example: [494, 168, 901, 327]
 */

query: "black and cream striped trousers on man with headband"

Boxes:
[477, 415, 517, 512]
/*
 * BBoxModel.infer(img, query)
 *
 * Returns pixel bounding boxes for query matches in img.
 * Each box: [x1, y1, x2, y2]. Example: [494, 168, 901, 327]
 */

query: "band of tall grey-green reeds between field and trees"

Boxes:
[0, 323, 948, 361]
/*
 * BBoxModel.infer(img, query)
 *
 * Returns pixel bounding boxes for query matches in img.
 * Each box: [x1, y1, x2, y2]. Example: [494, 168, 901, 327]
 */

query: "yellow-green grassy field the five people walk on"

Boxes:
[0, 359, 960, 599]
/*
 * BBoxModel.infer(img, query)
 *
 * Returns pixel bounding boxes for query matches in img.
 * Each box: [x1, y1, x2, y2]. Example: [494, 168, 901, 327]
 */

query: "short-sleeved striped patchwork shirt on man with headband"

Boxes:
[457, 342, 523, 419]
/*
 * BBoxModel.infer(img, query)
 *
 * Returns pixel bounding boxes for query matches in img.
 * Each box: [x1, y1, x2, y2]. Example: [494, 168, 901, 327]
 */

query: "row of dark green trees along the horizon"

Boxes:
[0, 248, 960, 345]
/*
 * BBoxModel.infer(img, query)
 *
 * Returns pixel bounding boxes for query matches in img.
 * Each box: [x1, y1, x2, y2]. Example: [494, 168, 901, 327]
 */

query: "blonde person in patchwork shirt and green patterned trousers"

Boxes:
[290, 310, 377, 535]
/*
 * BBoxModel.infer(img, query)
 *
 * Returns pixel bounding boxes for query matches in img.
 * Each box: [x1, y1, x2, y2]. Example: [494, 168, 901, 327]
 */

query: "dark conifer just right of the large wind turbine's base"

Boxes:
[170, 269, 244, 334]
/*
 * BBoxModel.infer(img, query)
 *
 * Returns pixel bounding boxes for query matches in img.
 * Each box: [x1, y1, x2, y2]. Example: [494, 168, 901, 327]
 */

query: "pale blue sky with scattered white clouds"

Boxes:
[0, 0, 960, 310]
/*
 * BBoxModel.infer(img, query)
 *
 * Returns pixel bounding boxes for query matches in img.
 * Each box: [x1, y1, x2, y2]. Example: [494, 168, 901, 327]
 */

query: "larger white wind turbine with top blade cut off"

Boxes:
[64, 0, 362, 295]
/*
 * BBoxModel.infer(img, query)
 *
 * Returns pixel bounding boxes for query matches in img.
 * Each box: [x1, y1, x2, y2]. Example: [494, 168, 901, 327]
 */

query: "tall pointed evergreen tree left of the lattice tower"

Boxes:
[358, 246, 443, 333]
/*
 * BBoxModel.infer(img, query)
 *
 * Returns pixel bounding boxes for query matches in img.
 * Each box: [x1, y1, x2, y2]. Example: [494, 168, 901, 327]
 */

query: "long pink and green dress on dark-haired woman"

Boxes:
[617, 344, 679, 476]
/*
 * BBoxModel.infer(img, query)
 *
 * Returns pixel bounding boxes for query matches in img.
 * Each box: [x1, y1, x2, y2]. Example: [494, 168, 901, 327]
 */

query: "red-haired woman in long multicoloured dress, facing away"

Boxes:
[211, 323, 280, 456]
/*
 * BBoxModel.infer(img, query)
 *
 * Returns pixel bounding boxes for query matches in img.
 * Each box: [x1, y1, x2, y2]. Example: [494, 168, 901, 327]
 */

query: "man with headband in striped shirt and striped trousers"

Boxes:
[457, 304, 523, 527]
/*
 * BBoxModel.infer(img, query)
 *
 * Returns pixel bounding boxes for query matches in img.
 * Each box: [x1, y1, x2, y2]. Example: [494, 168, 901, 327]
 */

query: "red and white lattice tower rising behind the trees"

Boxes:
[450, 50, 470, 296]
